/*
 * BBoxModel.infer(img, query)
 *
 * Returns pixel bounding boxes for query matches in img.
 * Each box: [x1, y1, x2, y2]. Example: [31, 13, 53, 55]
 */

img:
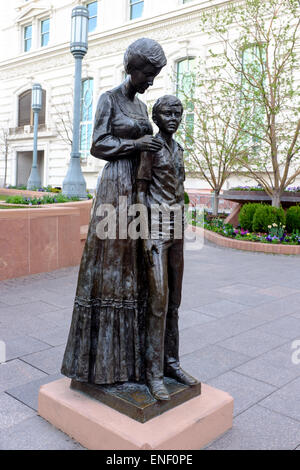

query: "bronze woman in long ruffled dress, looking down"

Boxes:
[61, 38, 167, 384]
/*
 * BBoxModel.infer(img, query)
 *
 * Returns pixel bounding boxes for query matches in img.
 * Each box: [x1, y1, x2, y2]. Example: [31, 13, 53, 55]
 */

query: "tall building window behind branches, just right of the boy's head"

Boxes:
[176, 57, 196, 151]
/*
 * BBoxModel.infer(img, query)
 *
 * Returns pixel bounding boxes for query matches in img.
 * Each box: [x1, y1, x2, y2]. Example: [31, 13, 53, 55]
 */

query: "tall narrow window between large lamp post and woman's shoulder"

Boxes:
[80, 78, 94, 159]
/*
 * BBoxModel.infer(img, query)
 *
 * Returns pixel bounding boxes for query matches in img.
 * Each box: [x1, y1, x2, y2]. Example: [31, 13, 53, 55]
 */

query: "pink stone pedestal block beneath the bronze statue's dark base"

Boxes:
[39, 378, 233, 450]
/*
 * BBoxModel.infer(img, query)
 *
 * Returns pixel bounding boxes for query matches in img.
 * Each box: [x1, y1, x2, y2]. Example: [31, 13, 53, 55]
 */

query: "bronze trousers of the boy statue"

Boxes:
[146, 239, 183, 379]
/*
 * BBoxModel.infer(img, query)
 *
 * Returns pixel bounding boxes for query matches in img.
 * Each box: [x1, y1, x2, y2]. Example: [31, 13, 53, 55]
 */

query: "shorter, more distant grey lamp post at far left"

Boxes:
[27, 83, 43, 189]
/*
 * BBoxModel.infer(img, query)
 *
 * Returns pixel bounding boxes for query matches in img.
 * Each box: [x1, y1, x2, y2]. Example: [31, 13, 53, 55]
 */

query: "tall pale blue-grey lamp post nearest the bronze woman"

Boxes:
[62, 6, 89, 199]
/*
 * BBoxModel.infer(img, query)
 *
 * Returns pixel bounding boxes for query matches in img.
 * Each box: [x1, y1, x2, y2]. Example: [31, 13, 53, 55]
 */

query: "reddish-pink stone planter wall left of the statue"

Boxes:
[0, 200, 92, 280]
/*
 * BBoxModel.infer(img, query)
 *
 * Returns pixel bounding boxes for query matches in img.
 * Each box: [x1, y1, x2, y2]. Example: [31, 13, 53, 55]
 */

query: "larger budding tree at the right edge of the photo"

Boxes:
[201, 0, 300, 207]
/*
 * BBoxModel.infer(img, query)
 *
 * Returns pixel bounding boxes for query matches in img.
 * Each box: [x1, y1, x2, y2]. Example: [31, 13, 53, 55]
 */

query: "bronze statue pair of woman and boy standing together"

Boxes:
[62, 38, 199, 408]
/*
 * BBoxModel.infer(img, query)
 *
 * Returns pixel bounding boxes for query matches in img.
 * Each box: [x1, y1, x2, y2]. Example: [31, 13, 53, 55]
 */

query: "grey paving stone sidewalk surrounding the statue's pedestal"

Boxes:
[0, 243, 300, 450]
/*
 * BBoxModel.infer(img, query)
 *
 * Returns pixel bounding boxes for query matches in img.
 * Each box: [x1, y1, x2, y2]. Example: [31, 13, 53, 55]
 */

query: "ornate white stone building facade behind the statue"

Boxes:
[0, 0, 296, 190]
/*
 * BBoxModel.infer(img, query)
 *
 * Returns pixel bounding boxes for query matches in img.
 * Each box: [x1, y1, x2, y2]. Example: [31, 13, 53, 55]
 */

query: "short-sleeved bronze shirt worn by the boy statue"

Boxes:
[137, 134, 185, 208]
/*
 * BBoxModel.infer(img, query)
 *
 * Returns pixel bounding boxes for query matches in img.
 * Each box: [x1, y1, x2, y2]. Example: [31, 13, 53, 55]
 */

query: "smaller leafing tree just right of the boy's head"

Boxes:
[177, 61, 247, 215]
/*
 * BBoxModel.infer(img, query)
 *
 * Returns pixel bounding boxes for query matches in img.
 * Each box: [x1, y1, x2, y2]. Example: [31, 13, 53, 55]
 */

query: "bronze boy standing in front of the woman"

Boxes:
[137, 95, 198, 400]
